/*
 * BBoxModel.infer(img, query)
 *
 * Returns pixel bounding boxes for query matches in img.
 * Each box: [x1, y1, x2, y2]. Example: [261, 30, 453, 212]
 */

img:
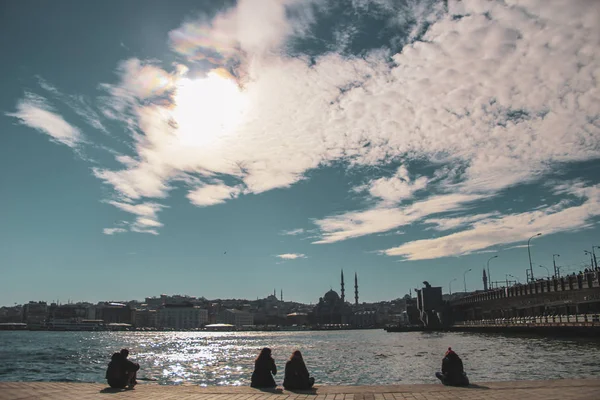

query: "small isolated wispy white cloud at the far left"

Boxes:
[6, 93, 83, 147]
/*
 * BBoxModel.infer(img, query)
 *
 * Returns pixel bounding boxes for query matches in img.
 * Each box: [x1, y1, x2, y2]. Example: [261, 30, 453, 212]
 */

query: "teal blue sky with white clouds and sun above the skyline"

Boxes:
[0, 0, 600, 305]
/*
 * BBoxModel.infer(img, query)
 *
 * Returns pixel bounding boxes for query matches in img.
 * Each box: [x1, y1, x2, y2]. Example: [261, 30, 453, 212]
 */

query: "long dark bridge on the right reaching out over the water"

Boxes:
[416, 270, 600, 331]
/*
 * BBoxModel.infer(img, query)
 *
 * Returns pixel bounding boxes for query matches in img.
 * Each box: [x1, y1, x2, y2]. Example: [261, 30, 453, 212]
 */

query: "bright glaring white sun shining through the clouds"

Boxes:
[172, 70, 247, 147]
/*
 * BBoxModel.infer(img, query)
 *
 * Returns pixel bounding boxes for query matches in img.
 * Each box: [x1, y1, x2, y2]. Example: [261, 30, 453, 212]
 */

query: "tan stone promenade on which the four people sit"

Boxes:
[0, 379, 600, 400]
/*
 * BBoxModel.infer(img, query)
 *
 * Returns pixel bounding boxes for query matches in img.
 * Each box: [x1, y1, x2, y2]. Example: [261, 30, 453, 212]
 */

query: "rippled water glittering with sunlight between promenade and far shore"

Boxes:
[0, 330, 600, 385]
